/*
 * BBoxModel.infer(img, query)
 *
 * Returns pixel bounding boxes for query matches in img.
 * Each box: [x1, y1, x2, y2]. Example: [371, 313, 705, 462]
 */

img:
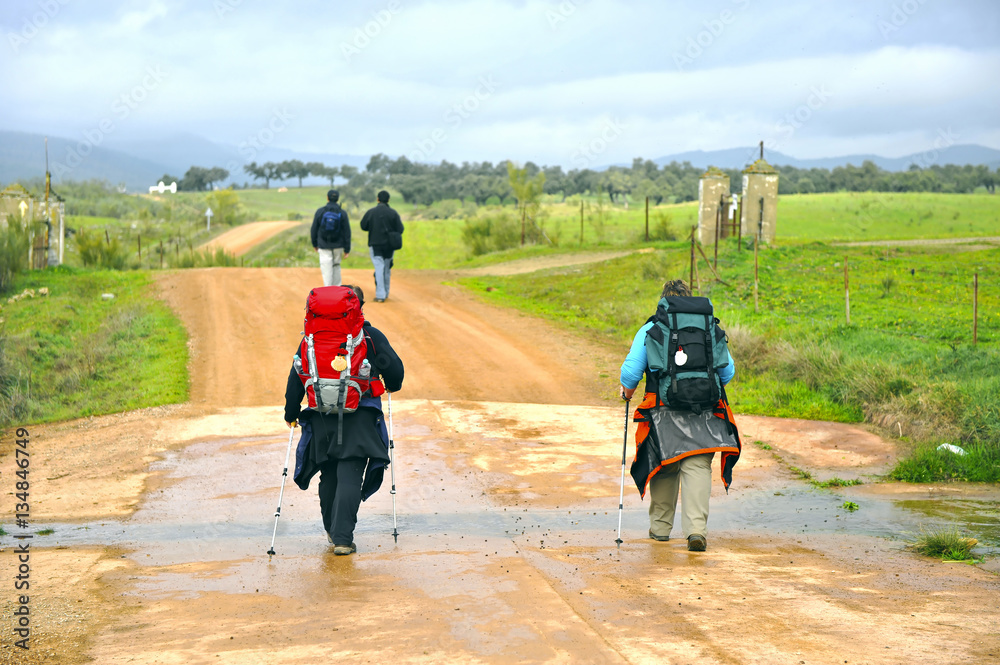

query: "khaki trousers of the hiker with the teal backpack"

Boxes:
[649, 453, 715, 538]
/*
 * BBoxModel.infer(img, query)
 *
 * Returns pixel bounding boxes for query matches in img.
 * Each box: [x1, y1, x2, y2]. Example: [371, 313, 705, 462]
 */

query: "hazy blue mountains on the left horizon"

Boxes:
[0, 131, 369, 192]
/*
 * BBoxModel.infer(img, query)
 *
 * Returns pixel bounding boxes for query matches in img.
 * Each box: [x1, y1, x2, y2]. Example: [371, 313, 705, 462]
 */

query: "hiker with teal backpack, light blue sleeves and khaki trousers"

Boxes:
[621, 280, 741, 552]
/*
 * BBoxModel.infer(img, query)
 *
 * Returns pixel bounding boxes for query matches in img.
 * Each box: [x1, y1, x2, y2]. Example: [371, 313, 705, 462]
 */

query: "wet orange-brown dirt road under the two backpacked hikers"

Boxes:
[0, 269, 1000, 663]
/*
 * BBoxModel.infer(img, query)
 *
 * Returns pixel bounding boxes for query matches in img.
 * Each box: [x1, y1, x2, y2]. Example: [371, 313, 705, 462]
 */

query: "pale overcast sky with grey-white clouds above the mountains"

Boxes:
[0, 0, 1000, 167]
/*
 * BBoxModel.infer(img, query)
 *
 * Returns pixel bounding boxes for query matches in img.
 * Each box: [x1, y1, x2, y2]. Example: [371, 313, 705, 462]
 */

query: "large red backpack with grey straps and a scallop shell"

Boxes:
[295, 286, 385, 434]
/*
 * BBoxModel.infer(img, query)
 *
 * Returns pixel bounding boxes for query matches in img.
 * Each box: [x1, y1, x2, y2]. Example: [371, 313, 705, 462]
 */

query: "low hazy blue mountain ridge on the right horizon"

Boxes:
[648, 145, 1000, 171]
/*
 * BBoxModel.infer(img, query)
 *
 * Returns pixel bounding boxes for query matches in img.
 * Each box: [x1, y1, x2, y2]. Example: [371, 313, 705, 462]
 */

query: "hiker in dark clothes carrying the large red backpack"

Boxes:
[282, 286, 403, 555]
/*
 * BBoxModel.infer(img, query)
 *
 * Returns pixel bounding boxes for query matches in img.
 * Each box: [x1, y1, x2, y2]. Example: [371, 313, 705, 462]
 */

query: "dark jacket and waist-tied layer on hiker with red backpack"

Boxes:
[285, 321, 403, 499]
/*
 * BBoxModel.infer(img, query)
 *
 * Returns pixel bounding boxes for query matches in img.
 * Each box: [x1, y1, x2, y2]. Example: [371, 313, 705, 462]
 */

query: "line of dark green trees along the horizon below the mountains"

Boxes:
[164, 153, 1000, 205]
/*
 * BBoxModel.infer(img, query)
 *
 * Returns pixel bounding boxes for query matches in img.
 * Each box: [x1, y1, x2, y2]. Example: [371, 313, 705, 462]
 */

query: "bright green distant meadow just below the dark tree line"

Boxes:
[239, 187, 1000, 269]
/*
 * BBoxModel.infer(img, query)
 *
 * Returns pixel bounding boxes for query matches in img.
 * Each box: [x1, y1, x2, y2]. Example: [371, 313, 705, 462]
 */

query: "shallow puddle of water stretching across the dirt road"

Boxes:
[0, 438, 1000, 565]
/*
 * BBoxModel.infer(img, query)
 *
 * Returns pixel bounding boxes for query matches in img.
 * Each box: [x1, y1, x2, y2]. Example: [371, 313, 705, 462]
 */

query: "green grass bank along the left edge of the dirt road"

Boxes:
[0, 268, 188, 428]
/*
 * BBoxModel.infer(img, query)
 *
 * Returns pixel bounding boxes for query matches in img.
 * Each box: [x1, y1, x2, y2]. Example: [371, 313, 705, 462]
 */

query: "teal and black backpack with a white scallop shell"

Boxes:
[646, 296, 729, 413]
